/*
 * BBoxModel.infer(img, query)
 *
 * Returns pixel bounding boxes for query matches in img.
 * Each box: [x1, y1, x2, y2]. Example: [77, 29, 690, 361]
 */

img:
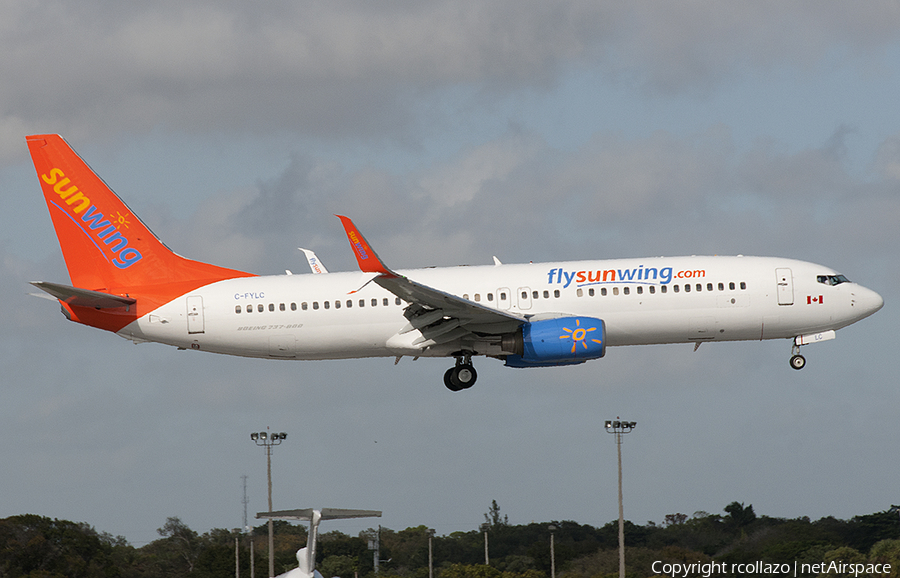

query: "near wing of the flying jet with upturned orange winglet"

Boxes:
[337, 215, 527, 348]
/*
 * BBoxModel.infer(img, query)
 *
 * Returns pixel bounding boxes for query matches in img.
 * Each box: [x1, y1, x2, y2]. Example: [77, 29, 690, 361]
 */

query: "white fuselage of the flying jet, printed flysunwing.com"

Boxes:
[119, 256, 883, 359]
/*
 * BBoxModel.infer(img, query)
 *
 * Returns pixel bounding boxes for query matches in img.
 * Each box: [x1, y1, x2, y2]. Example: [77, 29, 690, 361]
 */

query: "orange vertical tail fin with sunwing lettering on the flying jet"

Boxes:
[26, 134, 251, 290]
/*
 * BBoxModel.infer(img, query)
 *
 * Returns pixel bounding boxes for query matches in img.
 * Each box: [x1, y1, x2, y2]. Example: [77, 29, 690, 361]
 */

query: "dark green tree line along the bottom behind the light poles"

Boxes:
[0, 502, 900, 578]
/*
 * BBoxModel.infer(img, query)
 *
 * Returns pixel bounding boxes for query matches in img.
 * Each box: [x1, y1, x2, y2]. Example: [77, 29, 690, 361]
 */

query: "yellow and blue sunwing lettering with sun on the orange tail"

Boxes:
[41, 168, 143, 269]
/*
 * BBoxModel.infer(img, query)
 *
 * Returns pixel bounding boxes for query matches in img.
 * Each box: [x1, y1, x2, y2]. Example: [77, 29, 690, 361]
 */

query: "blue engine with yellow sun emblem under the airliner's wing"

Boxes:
[506, 317, 606, 367]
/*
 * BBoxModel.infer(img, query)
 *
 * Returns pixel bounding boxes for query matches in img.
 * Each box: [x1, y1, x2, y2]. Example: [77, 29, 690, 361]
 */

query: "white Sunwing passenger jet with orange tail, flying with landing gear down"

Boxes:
[26, 134, 884, 391]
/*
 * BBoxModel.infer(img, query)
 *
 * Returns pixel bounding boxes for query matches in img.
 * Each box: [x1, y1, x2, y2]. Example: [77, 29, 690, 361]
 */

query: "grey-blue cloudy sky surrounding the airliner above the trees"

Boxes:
[0, 0, 900, 545]
